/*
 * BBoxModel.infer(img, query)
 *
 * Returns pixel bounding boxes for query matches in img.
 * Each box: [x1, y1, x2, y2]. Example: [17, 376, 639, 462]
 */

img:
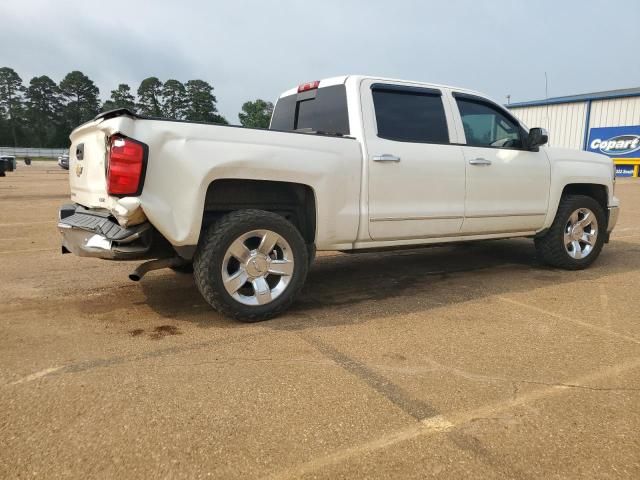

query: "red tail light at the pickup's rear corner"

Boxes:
[107, 135, 147, 196]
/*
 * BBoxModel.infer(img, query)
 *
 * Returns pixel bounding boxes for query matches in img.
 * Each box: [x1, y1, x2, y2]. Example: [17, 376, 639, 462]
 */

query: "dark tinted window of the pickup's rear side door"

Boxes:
[372, 86, 449, 143]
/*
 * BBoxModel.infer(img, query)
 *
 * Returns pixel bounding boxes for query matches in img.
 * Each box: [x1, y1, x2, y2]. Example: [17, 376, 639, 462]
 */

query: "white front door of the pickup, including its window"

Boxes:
[454, 93, 551, 235]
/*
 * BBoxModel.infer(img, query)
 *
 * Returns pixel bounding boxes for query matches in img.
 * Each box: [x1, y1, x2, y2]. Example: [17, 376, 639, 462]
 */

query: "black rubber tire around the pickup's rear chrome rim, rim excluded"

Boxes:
[193, 210, 309, 322]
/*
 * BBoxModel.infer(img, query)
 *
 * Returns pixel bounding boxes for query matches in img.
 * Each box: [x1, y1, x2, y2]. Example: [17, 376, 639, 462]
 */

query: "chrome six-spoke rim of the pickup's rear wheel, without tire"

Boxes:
[222, 230, 295, 305]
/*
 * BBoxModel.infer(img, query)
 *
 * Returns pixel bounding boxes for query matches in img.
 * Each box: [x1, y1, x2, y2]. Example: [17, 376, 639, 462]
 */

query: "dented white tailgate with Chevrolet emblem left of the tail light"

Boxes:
[69, 120, 108, 208]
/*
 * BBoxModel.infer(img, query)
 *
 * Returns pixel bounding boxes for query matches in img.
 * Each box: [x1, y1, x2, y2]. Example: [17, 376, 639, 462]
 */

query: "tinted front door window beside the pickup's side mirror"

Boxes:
[456, 98, 522, 148]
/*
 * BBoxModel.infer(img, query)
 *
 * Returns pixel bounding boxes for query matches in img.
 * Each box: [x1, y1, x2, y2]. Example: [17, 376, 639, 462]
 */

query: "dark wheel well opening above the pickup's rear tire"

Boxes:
[202, 179, 316, 244]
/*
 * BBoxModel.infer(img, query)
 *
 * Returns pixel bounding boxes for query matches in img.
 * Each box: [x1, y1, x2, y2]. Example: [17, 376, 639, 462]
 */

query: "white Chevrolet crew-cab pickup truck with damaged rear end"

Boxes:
[58, 76, 618, 321]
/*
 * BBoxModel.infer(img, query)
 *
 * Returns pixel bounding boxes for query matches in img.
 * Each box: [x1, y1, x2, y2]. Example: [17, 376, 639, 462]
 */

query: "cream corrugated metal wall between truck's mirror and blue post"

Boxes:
[511, 102, 593, 150]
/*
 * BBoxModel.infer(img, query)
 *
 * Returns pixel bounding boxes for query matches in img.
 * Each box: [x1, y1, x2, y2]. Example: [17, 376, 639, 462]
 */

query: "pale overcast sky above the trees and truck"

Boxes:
[0, 0, 640, 123]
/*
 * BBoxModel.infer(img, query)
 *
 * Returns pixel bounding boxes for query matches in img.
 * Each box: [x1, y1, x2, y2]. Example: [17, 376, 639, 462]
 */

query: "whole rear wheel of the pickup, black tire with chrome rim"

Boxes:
[193, 210, 308, 322]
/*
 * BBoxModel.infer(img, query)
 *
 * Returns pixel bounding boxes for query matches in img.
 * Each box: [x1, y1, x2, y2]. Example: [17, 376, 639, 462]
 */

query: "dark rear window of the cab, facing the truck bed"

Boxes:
[269, 85, 349, 135]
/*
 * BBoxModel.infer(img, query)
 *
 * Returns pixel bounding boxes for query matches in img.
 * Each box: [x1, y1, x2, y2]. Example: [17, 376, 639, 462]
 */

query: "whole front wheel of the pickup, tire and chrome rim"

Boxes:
[535, 195, 607, 270]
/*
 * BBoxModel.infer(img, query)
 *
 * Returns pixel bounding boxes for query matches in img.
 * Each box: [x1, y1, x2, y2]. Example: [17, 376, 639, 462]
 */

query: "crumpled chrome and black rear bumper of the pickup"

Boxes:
[58, 205, 154, 260]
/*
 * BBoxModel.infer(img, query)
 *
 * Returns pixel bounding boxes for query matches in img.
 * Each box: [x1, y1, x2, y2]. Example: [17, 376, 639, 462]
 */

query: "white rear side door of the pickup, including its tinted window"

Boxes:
[361, 80, 465, 244]
